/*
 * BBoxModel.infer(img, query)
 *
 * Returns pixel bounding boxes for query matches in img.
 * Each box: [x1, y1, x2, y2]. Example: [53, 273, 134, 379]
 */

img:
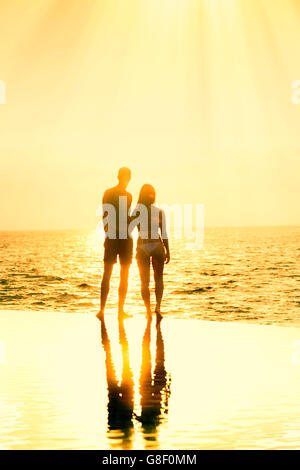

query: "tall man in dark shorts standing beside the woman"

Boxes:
[97, 167, 133, 319]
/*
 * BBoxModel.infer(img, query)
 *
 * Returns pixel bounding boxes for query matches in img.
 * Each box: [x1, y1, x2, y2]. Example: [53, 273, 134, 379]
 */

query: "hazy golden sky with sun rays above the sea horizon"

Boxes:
[0, 0, 300, 229]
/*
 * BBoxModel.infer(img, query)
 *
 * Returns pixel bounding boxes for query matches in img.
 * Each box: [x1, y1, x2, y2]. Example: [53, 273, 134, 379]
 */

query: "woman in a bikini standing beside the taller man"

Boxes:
[136, 184, 170, 321]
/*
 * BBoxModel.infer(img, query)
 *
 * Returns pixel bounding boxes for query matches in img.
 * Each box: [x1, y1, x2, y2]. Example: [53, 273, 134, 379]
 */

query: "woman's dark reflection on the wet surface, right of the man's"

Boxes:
[136, 319, 171, 440]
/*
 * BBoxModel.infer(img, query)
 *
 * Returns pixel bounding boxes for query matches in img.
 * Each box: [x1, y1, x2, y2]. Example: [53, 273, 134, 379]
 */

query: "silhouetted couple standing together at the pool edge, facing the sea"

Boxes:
[97, 167, 170, 321]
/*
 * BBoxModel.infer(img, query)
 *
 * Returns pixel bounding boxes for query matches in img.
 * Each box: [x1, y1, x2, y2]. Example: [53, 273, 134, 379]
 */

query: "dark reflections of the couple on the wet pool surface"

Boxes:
[101, 317, 170, 447]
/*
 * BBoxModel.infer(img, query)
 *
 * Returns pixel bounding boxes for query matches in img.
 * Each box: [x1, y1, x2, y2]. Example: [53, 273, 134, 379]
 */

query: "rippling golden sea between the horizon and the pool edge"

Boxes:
[0, 226, 300, 325]
